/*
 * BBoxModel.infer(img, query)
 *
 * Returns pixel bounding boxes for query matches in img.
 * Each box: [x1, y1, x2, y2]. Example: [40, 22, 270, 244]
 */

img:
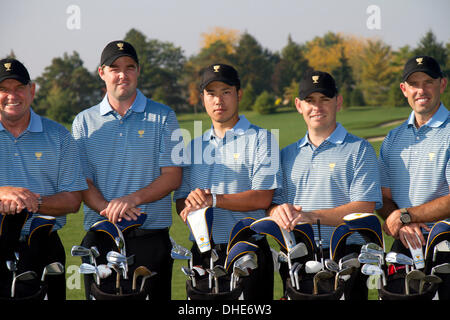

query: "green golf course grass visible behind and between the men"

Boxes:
[60, 107, 411, 300]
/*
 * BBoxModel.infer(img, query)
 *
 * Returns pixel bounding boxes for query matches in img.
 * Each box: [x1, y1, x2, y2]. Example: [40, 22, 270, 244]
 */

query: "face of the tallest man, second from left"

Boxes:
[98, 56, 139, 101]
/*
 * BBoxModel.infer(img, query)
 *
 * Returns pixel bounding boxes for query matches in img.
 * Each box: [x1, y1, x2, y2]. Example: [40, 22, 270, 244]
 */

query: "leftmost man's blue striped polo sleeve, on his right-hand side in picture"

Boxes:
[57, 129, 88, 192]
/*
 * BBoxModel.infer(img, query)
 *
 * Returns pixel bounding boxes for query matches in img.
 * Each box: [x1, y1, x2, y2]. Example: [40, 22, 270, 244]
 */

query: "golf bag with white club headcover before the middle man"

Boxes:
[186, 215, 273, 300]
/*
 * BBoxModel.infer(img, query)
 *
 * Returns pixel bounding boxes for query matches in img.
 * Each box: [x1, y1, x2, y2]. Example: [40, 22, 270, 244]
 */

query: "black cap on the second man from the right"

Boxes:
[298, 71, 338, 100]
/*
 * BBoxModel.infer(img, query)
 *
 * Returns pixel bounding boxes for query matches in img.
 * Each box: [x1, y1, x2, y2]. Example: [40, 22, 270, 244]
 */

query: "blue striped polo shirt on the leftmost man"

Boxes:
[0, 108, 88, 235]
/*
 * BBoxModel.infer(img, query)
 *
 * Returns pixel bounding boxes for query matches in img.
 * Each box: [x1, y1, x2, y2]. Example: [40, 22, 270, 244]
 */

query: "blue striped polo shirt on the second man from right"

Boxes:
[274, 123, 382, 247]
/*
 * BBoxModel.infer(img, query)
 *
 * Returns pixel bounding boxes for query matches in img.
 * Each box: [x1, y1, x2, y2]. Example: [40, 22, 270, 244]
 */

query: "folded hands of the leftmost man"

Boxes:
[0, 186, 39, 214]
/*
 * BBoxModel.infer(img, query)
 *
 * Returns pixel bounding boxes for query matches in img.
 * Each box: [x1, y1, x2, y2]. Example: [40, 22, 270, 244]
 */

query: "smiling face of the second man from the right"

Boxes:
[295, 92, 342, 131]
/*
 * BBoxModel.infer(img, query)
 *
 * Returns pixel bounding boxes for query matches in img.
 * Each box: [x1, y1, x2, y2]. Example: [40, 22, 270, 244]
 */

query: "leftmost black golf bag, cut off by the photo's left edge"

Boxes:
[0, 210, 65, 300]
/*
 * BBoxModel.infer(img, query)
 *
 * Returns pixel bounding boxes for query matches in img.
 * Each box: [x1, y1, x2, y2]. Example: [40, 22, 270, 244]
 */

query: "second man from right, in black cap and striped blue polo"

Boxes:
[268, 71, 382, 299]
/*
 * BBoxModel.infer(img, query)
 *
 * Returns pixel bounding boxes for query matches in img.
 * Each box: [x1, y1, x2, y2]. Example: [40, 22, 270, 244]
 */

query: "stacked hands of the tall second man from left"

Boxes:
[100, 195, 141, 223]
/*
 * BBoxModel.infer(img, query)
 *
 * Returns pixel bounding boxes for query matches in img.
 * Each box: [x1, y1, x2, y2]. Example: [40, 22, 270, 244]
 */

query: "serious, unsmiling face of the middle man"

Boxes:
[202, 81, 242, 125]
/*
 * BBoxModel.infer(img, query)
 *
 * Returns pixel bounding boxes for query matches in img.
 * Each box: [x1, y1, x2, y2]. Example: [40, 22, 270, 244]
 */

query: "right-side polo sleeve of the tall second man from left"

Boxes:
[159, 110, 184, 167]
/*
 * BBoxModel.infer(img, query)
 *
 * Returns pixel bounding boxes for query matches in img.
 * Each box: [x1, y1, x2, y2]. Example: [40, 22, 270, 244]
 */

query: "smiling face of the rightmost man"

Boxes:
[400, 72, 447, 118]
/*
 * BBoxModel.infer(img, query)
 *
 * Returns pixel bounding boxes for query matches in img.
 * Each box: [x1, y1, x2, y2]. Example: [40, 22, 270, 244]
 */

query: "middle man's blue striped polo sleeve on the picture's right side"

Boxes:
[251, 129, 282, 190]
